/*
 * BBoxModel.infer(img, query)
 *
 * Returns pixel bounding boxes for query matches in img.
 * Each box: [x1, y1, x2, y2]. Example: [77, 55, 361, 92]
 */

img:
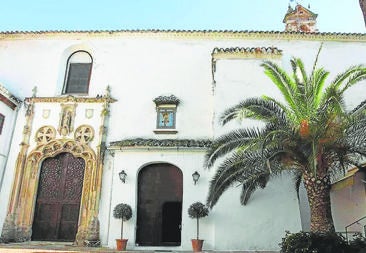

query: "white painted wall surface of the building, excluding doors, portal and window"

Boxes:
[0, 33, 366, 250]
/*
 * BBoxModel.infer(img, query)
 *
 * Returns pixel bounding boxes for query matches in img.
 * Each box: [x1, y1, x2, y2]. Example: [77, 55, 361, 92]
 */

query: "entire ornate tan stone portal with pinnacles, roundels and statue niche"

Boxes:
[1, 89, 115, 245]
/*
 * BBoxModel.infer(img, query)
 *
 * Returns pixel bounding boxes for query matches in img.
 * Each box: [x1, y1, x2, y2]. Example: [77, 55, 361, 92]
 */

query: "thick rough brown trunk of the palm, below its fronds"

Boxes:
[304, 173, 335, 232]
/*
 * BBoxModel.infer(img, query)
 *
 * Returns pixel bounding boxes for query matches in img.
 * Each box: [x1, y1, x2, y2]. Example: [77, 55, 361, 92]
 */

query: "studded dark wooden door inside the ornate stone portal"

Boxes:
[32, 153, 85, 241]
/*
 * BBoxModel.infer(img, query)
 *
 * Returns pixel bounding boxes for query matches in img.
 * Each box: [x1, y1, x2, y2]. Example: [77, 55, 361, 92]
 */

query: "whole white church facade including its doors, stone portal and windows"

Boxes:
[0, 30, 366, 250]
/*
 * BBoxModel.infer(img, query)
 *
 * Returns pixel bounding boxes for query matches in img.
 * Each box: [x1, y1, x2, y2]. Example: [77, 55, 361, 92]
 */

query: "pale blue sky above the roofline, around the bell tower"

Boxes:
[0, 0, 366, 33]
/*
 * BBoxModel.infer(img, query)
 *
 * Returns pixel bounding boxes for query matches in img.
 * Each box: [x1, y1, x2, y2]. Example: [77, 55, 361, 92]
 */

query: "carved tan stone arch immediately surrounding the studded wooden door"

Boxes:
[7, 139, 102, 245]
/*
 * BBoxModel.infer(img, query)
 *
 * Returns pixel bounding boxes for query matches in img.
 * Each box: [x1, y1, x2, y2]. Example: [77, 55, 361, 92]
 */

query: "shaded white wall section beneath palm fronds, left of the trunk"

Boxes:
[211, 175, 301, 250]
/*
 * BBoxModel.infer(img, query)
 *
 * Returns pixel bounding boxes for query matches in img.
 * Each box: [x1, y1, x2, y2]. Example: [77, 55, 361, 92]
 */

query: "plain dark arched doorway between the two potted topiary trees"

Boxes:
[136, 163, 183, 246]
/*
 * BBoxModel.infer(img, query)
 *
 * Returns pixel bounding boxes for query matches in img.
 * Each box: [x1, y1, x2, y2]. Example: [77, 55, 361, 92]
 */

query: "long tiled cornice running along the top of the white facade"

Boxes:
[0, 30, 366, 42]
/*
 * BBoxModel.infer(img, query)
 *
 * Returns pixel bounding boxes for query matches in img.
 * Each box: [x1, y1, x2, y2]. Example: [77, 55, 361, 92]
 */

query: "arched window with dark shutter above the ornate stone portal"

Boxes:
[62, 51, 93, 94]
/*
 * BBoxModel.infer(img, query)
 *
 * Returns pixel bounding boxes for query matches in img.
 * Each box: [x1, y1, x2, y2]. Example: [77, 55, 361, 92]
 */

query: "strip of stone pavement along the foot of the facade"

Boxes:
[0, 242, 278, 253]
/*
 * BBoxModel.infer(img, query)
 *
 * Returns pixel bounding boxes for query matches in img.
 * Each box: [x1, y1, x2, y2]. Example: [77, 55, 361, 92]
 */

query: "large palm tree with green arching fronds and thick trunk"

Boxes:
[205, 46, 366, 232]
